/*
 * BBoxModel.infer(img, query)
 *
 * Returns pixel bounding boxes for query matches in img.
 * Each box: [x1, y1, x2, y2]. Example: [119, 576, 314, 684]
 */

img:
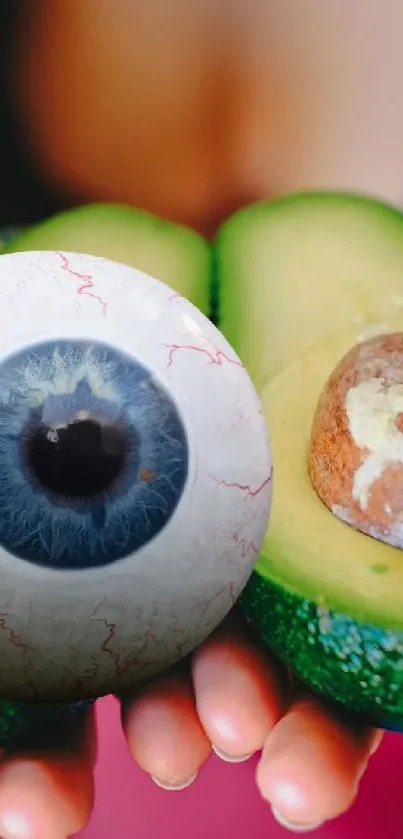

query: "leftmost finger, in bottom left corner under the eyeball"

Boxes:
[0, 708, 96, 839]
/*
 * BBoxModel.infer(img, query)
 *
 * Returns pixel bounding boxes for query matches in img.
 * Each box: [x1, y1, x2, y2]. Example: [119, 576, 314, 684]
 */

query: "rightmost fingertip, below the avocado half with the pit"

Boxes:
[257, 698, 381, 830]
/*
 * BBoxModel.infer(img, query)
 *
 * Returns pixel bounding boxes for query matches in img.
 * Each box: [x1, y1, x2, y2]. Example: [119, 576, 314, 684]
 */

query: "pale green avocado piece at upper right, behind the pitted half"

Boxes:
[215, 193, 403, 391]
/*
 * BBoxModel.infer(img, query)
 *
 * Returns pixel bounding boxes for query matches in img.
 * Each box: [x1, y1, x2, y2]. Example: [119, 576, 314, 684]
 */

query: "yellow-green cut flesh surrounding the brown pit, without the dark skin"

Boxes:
[256, 332, 403, 628]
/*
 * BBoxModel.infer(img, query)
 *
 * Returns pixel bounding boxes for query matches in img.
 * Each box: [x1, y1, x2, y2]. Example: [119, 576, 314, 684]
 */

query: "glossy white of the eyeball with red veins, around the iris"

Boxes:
[0, 252, 272, 701]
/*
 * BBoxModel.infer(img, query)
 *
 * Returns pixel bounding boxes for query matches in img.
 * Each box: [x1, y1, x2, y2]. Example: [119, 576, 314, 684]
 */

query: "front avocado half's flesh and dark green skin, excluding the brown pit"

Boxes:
[242, 342, 403, 727]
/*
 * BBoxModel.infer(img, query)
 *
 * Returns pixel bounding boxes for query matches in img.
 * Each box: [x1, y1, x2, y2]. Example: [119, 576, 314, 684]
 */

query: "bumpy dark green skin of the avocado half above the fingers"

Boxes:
[240, 571, 403, 732]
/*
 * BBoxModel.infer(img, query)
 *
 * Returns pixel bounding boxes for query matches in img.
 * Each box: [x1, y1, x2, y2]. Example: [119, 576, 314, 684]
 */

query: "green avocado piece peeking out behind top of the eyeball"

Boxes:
[5, 204, 211, 315]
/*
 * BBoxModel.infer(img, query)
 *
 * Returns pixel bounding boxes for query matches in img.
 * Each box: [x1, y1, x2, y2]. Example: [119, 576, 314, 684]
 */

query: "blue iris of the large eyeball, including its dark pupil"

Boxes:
[0, 341, 188, 569]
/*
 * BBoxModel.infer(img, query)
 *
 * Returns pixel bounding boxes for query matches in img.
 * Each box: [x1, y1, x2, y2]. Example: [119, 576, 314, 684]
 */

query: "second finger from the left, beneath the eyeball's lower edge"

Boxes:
[122, 667, 211, 789]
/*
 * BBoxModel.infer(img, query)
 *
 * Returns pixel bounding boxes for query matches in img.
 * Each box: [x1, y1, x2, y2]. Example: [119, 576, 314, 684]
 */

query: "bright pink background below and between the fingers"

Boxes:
[79, 698, 403, 839]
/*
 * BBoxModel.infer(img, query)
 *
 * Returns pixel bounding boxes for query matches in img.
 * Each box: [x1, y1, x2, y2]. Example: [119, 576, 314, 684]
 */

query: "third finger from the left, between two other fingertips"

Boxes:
[192, 615, 286, 762]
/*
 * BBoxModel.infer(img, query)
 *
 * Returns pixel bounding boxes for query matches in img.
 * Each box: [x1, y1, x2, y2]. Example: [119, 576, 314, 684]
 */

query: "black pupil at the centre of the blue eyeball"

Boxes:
[25, 418, 129, 498]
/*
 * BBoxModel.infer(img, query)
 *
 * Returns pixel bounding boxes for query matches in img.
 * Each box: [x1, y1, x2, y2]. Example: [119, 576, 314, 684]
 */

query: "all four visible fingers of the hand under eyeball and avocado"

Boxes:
[0, 612, 382, 839]
